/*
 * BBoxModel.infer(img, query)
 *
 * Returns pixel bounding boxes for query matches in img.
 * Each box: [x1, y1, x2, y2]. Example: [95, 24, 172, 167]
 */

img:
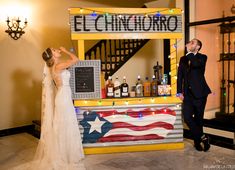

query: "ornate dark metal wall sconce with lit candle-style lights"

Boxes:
[5, 17, 28, 40]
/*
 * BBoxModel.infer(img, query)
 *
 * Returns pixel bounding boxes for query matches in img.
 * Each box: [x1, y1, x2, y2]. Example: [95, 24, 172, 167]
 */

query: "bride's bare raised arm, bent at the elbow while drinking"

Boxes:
[56, 47, 79, 70]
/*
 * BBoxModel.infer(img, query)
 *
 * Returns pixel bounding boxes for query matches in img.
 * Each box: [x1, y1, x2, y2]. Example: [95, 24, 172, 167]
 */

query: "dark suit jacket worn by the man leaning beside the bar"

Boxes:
[177, 53, 211, 99]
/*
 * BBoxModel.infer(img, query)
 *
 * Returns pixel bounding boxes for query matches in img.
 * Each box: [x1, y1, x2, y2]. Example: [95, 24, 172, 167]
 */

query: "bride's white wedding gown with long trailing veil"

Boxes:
[13, 66, 85, 170]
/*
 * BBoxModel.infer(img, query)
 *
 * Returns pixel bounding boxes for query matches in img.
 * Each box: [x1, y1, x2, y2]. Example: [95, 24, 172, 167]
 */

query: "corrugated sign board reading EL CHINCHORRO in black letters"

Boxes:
[70, 14, 182, 34]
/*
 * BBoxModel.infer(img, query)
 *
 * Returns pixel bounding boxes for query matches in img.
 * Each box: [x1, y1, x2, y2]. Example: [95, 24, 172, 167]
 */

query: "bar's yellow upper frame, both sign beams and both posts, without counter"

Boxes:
[69, 8, 183, 96]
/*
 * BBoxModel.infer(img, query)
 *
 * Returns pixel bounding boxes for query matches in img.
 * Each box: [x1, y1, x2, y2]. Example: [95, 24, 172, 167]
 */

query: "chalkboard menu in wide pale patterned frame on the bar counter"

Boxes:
[69, 60, 101, 99]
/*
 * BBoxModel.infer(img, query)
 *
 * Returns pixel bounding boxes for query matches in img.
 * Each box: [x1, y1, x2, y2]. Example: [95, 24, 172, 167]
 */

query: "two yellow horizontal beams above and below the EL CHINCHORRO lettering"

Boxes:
[69, 8, 182, 40]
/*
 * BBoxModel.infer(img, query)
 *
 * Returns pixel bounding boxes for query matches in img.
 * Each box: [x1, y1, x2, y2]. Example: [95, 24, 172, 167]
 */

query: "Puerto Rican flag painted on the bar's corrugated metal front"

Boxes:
[80, 108, 176, 143]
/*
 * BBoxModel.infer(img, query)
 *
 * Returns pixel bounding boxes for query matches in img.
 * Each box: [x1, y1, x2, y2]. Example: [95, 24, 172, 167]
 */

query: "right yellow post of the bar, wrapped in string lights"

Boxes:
[170, 39, 177, 96]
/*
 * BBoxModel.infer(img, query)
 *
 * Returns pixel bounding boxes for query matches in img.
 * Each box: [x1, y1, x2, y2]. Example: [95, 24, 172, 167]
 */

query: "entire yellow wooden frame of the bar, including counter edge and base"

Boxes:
[69, 8, 184, 154]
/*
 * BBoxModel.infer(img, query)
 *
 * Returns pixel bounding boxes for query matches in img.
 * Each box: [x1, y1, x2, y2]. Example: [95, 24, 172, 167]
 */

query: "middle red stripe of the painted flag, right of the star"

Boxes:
[112, 122, 174, 131]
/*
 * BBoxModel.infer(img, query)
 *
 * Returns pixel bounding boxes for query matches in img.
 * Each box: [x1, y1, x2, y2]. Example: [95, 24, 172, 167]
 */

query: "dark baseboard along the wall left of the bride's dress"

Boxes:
[0, 125, 34, 137]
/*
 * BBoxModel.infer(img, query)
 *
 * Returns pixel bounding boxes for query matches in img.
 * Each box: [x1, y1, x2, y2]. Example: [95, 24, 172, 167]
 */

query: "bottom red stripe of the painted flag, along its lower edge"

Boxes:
[97, 134, 164, 142]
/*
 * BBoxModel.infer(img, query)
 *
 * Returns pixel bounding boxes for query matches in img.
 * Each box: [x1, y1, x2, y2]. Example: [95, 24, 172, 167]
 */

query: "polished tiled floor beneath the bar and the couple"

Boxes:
[0, 133, 235, 170]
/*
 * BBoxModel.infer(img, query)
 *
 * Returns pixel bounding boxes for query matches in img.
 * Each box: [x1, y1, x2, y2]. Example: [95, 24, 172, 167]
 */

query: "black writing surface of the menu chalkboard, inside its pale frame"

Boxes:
[75, 67, 95, 93]
